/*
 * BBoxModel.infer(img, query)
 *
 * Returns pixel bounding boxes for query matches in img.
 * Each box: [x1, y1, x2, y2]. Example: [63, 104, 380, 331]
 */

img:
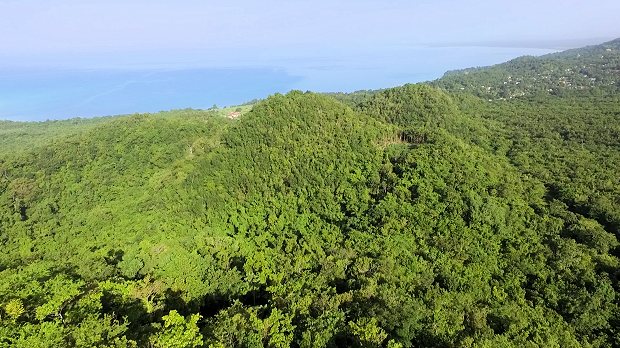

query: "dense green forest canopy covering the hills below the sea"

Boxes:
[0, 41, 620, 347]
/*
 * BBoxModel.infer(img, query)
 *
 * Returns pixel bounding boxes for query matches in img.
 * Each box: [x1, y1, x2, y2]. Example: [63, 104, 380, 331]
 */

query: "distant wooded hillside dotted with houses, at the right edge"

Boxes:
[433, 39, 620, 99]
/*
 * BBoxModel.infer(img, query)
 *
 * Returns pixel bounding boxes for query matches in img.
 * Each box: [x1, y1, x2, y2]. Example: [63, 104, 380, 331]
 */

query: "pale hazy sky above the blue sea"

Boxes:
[0, 0, 620, 66]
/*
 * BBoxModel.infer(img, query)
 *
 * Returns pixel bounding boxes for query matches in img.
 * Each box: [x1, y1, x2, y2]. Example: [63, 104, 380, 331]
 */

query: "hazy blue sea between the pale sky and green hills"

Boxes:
[0, 46, 554, 121]
